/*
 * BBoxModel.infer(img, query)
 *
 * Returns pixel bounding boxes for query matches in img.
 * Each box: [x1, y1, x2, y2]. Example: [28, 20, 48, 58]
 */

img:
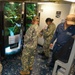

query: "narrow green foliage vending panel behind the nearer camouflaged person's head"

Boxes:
[24, 2, 37, 32]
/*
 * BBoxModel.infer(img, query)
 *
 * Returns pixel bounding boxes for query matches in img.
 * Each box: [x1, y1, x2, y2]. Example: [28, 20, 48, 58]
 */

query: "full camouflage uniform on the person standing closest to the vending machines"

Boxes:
[21, 25, 38, 72]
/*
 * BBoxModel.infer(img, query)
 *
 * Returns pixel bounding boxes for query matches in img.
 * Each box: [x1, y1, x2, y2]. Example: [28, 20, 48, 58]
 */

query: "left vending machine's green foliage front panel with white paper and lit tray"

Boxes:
[4, 2, 22, 54]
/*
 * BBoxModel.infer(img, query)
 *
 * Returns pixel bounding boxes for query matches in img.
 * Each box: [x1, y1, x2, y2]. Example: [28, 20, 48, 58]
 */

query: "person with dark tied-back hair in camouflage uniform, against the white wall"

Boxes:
[42, 18, 56, 59]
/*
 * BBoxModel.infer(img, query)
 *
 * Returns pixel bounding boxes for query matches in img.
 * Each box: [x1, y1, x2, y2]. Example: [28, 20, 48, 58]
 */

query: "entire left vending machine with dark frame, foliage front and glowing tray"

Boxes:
[0, 1, 22, 55]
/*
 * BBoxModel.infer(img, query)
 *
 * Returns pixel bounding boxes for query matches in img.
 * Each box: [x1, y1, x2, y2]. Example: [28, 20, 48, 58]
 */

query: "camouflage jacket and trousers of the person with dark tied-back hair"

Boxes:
[43, 23, 56, 57]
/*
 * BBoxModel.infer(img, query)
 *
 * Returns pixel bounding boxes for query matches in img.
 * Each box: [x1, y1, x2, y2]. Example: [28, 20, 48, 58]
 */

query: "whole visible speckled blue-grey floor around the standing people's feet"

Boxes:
[2, 47, 51, 75]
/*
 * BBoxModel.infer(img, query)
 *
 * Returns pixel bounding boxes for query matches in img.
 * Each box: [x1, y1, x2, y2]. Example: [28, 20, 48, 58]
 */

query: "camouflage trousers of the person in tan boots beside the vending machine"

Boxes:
[21, 47, 36, 72]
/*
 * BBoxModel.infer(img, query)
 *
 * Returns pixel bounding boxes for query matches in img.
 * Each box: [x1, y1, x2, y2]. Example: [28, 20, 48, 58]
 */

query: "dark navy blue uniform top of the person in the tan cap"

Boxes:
[51, 23, 75, 51]
